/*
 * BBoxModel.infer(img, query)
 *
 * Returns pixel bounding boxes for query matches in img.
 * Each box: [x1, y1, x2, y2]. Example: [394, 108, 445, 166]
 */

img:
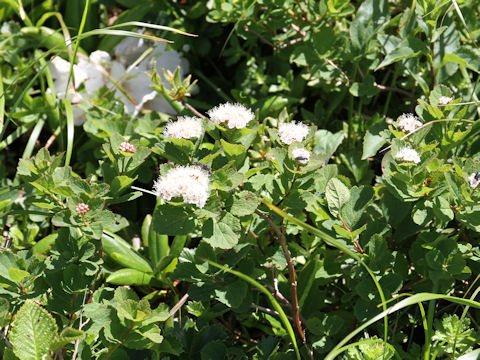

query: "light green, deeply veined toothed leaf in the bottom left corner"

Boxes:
[9, 300, 58, 360]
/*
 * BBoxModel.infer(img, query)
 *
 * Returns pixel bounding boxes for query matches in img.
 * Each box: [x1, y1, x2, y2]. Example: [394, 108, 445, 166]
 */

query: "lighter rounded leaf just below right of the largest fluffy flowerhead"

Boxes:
[202, 213, 241, 249]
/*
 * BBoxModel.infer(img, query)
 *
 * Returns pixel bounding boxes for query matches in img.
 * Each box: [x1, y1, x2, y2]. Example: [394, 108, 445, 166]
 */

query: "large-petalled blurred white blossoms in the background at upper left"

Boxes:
[49, 37, 189, 125]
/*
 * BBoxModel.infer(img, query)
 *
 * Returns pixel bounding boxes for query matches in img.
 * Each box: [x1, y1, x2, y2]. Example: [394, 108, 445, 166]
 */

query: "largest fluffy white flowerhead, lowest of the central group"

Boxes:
[153, 166, 208, 208]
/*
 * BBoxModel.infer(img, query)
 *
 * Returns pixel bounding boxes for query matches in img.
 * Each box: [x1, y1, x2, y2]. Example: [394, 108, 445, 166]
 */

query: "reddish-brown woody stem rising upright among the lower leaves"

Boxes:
[256, 211, 306, 344]
